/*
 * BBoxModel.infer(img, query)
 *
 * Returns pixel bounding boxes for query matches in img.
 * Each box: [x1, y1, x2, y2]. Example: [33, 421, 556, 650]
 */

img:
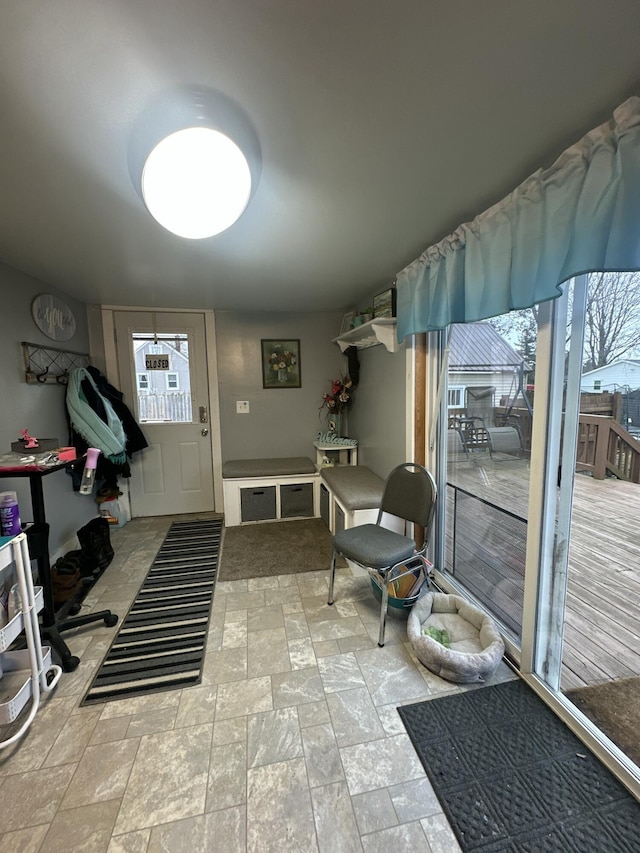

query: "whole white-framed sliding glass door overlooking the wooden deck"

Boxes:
[430, 276, 640, 794]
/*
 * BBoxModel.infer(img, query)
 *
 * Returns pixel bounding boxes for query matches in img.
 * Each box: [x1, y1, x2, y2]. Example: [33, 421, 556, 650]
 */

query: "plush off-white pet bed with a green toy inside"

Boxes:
[407, 592, 504, 684]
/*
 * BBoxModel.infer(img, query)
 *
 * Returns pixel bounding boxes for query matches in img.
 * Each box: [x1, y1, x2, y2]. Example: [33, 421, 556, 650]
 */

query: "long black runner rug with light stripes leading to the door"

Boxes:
[81, 519, 222, 705]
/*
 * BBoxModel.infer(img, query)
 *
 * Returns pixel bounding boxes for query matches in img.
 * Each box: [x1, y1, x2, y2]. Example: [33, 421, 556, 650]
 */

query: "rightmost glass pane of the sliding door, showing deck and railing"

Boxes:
[552, 273, 640, 765]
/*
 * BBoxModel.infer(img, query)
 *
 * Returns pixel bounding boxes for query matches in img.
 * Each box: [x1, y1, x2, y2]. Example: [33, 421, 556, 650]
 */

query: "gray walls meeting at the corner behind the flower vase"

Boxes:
[216, 312, 406, 477]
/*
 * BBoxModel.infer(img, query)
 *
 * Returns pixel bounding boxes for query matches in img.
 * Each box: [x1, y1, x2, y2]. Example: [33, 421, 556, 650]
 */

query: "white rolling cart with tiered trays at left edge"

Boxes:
[0, 533, 62, 749]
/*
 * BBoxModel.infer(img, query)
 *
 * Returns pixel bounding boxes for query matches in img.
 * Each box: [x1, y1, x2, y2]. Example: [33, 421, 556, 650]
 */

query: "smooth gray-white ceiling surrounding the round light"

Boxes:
[0, 0, 640, 310]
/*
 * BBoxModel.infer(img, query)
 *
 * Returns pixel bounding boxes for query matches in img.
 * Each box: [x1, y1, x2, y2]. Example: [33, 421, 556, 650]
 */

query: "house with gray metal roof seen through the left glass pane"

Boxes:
[448, 323, 529, 417]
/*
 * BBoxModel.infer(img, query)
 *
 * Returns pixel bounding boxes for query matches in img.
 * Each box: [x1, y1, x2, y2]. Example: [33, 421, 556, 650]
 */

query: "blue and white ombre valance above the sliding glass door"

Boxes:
[397, 97, 640, 341]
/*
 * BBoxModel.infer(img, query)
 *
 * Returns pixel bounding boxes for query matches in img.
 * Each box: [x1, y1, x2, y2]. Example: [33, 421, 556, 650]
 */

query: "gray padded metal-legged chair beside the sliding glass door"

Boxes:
[327, 462, 437, 646]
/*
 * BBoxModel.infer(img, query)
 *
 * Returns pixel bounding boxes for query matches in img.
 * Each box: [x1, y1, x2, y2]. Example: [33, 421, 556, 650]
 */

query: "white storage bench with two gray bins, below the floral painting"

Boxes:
[222, 456, 320, 527]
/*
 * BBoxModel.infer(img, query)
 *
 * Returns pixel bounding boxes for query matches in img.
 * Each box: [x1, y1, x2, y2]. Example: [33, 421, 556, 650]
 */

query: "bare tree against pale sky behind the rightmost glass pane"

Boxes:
[584, 272, 640, 370]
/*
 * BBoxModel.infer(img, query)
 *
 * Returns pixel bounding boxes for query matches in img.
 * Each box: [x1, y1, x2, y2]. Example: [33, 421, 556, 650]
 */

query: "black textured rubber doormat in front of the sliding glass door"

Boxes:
[398, 680, 640, 853]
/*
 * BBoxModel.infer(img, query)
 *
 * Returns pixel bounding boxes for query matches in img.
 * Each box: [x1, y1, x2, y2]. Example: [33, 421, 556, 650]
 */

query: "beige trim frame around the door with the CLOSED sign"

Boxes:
[94, 305, 224, 513]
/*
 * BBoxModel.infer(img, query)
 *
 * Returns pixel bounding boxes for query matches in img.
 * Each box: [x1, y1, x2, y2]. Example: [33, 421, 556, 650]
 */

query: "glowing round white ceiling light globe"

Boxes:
[141, 127, 251, 240]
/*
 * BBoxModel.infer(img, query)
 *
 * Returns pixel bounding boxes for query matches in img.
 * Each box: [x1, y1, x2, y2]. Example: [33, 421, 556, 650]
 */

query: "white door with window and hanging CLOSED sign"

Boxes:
[114, 311, 214, 518]
